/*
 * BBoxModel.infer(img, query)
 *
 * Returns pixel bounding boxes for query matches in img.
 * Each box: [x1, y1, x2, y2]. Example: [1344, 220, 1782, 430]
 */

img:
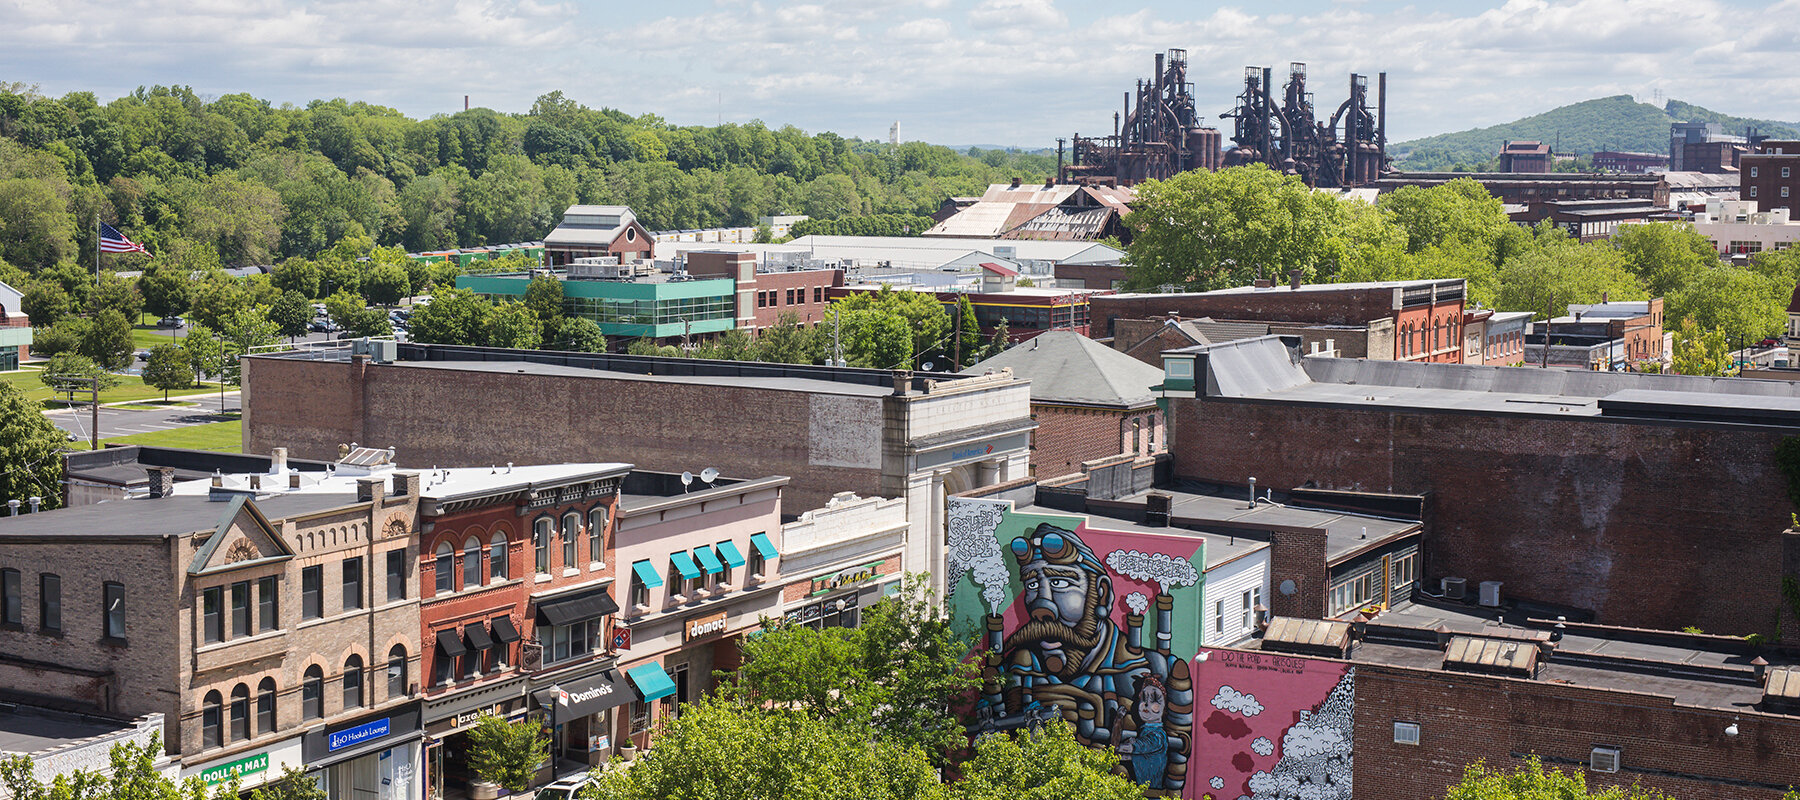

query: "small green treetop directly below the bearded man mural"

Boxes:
[952, 719, 1145, 800]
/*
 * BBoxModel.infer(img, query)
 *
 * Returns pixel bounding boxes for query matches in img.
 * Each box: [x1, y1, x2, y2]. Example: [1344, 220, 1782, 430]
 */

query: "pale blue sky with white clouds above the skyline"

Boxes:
[0, 0, 1800, 148]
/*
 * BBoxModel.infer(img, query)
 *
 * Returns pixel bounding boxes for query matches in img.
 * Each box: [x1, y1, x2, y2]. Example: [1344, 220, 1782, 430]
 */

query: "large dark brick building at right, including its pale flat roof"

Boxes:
[1165, 339, 1800, 634]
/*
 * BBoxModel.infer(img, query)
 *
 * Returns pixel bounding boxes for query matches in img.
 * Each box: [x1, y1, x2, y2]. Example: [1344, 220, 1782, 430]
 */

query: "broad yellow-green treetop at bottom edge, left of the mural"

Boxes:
[581, 697, 947, 800]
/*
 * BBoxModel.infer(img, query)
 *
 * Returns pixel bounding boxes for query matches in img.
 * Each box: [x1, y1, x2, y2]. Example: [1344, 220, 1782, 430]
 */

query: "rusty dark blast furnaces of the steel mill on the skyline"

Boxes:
[1057, 50, 1388, 187]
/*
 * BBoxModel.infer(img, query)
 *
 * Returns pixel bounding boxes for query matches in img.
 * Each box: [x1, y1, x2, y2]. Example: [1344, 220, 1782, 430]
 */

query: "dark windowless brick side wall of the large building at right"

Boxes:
[1172, 400, 1793, 634]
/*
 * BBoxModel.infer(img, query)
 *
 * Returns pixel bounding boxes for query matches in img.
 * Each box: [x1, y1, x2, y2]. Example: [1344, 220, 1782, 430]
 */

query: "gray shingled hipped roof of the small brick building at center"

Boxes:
[967, 330, 1163, 407]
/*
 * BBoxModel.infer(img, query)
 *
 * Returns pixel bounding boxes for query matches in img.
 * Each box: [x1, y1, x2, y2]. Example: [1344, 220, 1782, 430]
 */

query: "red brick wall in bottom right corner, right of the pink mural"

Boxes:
[1352, 663, 1800, 800]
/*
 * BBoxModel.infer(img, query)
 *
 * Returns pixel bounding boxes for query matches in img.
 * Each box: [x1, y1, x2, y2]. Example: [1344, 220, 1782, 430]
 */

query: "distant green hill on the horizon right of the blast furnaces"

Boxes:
[1390, 94, 1800, 171]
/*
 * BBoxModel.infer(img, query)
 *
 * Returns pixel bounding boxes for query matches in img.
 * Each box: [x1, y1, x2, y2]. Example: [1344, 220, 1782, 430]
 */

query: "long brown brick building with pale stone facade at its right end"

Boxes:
[243, 344, 1035, 594]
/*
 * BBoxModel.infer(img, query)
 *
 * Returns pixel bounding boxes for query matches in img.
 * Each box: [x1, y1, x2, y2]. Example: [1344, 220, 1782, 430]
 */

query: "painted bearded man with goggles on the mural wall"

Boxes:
[976, 523, 1193, 789]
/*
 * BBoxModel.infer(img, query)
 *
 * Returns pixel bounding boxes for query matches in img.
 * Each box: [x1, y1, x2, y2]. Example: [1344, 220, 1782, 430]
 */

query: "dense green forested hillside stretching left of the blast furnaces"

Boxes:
[0, 83, 1053, 270]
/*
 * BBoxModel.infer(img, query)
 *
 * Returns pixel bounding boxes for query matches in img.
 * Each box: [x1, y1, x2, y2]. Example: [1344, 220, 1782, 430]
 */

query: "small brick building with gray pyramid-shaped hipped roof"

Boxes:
[968, 332, 1168, 477]
